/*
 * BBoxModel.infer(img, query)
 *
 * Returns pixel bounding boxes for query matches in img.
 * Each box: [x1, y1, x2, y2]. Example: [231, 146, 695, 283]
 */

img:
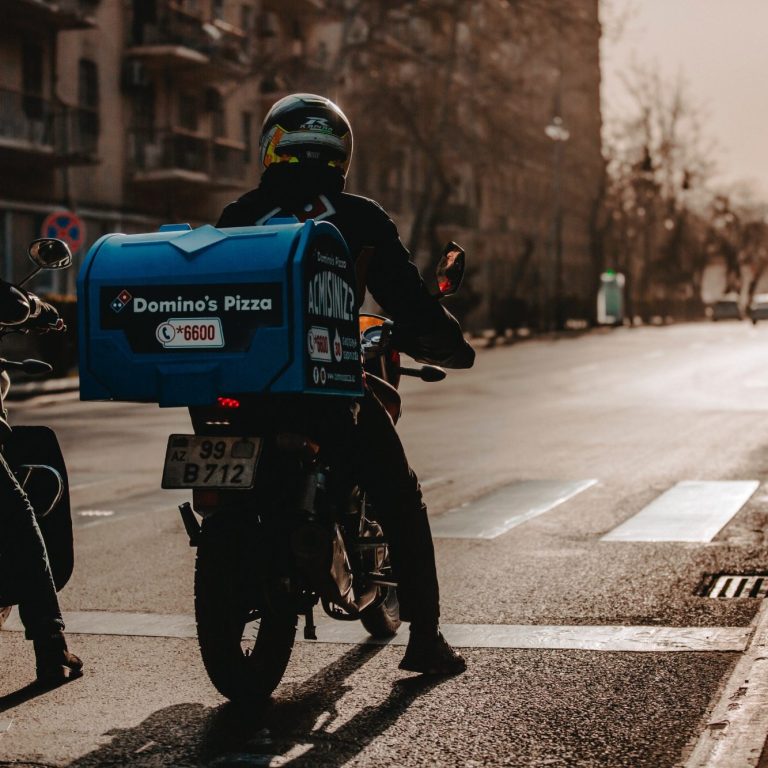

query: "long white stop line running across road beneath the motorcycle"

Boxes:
[3, 603, 748, 653]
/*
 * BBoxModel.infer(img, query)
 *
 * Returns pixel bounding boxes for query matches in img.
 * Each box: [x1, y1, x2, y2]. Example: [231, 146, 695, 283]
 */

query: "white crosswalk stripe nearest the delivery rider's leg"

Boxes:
[430, 480, 597, 539]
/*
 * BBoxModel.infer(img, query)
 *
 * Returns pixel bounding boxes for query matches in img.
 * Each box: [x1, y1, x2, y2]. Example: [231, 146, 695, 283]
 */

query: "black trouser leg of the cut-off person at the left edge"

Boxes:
[0, 454, 64, 639]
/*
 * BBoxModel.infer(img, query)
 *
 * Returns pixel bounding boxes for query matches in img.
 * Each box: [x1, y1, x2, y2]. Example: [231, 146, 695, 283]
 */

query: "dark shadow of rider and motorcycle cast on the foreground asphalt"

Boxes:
[70, 645, 450, 768]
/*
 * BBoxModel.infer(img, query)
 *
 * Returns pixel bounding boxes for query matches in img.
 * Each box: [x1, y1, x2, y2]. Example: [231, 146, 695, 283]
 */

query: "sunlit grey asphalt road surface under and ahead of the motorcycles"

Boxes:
[0, 323, 768, 768]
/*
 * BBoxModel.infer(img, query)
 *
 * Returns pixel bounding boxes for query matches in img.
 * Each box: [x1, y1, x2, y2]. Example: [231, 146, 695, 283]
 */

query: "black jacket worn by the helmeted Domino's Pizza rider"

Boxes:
[216, 165, 475, 368]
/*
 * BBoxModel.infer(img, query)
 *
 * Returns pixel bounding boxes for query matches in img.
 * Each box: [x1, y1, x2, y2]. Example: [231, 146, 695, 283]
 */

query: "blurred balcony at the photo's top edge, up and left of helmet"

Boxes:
[125, 0, 252, 79]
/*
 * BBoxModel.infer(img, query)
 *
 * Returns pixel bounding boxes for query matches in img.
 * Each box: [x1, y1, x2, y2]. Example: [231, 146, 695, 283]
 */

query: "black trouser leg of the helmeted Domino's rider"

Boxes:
[334, 391, 440, 624]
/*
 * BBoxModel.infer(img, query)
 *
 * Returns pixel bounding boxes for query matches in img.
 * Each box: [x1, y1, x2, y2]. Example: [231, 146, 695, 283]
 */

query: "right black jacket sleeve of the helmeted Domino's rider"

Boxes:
[366, 202, 475, 368]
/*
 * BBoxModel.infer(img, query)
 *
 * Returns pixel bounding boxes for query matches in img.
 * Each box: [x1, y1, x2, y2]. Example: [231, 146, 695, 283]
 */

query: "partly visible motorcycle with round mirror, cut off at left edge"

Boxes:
[0, 238, 74, 627]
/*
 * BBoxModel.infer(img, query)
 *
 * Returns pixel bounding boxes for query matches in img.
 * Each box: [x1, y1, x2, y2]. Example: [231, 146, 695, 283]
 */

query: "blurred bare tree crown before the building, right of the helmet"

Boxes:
[324, 0, 558, 268]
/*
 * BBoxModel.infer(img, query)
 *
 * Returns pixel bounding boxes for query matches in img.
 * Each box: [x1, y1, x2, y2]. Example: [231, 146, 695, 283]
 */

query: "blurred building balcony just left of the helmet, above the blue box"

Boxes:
[129, 130, 247, 192]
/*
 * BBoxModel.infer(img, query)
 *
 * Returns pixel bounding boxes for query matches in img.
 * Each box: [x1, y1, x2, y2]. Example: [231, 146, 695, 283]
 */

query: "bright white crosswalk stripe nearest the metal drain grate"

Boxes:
[601, 480, 760, 541]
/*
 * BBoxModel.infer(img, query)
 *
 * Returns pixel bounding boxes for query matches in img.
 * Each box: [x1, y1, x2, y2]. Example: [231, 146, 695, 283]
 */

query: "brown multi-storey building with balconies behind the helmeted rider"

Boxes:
[0, 0, 604, 328]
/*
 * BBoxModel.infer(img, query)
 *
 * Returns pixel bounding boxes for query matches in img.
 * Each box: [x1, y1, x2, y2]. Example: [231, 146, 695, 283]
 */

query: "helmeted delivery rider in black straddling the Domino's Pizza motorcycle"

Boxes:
[217, 93, 475, 674]
